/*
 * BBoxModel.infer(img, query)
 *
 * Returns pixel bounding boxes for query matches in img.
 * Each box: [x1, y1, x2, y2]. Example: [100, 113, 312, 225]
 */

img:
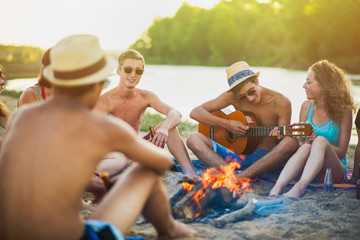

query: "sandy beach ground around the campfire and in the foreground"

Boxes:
[1, 96, 360, 240]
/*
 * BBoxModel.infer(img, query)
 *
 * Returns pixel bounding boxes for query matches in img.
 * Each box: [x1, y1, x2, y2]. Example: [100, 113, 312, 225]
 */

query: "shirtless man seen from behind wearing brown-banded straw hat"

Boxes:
[0, 35, 194, 240]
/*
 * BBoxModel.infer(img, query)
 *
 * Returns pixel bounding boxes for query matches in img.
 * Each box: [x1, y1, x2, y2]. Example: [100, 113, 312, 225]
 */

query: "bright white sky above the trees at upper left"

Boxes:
[0, 0, 218, 50]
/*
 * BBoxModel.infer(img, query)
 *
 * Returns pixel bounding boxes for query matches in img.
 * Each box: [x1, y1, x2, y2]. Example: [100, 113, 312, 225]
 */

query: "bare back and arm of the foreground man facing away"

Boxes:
[0, 98, 169, 239]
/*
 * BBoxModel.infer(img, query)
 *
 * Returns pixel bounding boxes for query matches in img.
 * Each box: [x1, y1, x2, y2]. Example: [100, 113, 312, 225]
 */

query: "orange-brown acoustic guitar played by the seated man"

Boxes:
[199, 110, 312, 154]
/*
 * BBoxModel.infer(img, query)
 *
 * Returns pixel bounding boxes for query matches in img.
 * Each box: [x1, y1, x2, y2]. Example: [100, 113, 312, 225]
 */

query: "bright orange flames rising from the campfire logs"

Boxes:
[182, 162, 252, 217]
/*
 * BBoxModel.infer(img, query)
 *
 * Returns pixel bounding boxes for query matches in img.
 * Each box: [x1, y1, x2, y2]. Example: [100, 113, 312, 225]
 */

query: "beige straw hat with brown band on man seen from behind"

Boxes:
[43, 34, 116, 87]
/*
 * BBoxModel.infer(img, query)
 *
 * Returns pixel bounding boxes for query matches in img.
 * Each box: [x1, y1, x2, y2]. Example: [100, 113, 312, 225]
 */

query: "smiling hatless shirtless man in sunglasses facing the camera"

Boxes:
[95, 49, 200, 179]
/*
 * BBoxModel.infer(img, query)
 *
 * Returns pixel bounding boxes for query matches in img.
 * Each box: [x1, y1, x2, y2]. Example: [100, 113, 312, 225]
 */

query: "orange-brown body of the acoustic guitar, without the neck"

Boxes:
[199, 110, 258, 154]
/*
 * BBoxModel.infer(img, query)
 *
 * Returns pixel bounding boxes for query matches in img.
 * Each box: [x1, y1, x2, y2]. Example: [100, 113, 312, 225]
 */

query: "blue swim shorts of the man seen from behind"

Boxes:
[81, 219, 124, 240]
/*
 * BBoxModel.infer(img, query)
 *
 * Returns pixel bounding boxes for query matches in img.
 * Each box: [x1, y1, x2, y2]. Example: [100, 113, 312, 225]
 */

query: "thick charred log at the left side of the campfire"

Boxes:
[173, 182, 216, 219]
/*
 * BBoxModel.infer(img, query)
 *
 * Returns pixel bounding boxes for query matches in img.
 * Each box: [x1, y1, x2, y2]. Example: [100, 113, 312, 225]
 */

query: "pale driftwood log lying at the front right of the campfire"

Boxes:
[212, 199, 257, 228]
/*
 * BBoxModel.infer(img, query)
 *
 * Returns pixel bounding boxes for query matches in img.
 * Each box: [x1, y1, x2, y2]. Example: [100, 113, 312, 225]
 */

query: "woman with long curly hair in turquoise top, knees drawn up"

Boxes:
[270, 60, 355, 199]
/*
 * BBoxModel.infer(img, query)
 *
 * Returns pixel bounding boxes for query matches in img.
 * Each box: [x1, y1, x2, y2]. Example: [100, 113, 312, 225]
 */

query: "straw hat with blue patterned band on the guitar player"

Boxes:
[226, 61, 260, 92]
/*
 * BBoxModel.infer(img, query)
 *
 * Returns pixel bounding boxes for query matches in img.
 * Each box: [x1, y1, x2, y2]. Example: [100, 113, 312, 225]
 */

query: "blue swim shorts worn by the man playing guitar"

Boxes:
[210, 139, 284, 178]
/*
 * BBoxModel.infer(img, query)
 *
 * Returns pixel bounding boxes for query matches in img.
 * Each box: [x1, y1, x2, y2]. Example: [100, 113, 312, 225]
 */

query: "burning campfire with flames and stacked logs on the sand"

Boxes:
[170, 162, 284, 228]
